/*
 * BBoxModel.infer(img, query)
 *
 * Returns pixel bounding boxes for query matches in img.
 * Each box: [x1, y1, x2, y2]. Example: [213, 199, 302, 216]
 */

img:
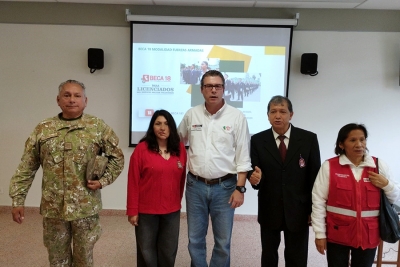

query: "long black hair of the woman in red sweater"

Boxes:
[139, 109, 180, 157]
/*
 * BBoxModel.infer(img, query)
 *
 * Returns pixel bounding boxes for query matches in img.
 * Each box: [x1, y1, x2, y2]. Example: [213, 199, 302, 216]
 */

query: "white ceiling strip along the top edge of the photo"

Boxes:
[0, 0, 400, 10]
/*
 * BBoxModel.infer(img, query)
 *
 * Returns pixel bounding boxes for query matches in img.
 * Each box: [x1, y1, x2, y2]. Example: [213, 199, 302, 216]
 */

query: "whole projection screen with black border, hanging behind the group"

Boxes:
[129, 18, 293, 146]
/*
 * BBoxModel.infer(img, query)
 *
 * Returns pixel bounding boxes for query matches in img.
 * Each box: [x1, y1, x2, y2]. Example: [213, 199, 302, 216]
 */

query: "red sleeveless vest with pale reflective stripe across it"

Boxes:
[326, 157, 380, 249]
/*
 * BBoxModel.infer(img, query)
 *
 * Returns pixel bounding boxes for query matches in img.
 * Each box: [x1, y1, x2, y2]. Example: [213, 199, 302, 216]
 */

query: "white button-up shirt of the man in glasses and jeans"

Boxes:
[178, 103, 252, 179]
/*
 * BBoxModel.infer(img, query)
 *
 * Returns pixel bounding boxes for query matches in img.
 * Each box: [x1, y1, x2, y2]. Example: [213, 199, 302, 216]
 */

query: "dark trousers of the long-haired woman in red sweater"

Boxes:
[135, 211, 181, 267]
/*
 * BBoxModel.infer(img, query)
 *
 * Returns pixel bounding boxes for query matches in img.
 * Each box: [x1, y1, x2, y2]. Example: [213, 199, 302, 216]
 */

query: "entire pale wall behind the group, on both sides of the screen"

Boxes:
[0, 24, 400, 214]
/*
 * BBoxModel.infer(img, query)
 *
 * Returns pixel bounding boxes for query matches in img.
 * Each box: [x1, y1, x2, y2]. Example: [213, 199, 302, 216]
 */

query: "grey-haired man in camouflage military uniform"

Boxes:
[10, 80, 124, 267]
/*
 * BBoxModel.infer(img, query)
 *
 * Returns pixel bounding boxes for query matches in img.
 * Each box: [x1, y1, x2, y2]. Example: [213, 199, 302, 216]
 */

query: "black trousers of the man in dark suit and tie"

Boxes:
[261, 224, 309, 267]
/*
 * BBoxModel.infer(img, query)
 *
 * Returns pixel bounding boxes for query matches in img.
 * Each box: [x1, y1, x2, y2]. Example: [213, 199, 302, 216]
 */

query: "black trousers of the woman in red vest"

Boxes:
[326, 242, 376, 267]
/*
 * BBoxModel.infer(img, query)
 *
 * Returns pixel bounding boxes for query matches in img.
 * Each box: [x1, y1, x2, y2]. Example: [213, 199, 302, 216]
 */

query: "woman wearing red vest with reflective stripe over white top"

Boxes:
[311, 123, 400, 267]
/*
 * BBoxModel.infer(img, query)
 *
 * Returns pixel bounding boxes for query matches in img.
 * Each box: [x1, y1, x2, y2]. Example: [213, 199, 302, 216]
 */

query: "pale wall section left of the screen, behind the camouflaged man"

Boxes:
[0, 24, 133, 209]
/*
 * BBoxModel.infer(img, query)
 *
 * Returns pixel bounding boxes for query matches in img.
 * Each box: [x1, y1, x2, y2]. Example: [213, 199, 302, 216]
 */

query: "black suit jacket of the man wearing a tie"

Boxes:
[248, 125, 321, 232]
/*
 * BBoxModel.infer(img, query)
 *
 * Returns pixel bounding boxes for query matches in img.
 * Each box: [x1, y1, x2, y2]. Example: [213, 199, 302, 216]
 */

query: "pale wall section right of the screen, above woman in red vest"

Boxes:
[289, 32, 400, 174]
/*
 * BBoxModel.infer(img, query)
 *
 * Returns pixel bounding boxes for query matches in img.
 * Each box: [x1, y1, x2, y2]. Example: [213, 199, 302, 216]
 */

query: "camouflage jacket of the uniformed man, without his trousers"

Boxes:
[10, 114, 124, 221]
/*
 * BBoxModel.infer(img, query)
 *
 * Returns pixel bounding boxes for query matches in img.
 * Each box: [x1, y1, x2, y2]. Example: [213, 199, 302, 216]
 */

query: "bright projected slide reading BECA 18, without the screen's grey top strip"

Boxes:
[131, 21, 290, 145]
